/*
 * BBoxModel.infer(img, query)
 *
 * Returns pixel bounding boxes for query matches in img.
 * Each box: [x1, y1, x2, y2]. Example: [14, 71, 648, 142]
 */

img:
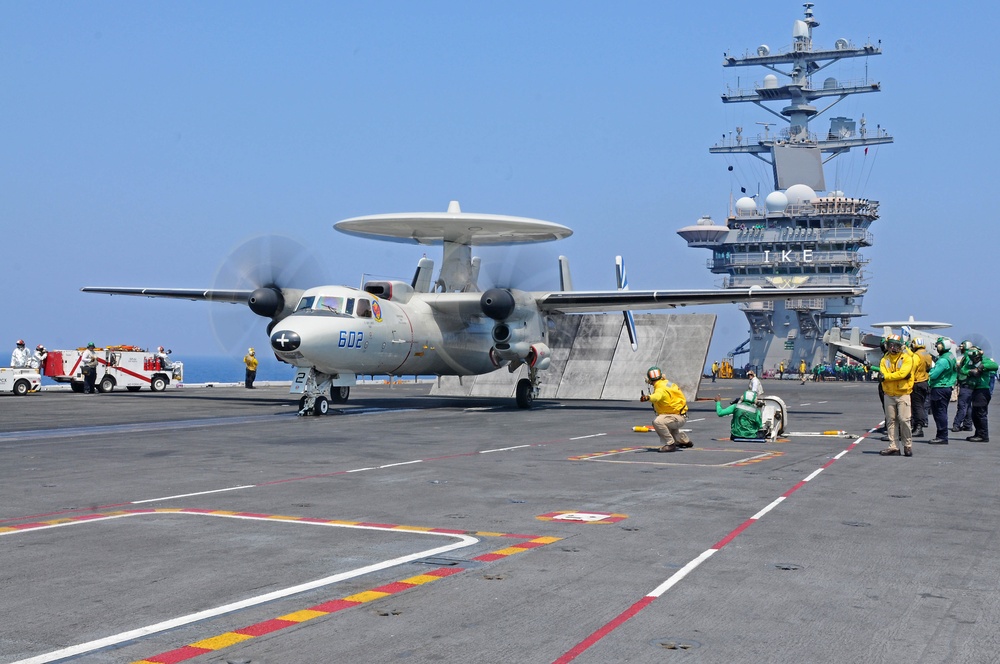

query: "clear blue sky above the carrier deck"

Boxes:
[0, 0, 1000, 368]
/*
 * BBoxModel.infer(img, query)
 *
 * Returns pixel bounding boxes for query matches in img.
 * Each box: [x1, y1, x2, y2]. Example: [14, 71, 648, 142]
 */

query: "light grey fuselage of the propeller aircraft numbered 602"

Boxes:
[271, 286, 496, 376]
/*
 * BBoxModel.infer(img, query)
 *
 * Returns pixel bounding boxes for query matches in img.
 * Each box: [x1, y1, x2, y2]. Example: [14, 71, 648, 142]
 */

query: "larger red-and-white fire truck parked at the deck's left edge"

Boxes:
[45, 346, 184, 392]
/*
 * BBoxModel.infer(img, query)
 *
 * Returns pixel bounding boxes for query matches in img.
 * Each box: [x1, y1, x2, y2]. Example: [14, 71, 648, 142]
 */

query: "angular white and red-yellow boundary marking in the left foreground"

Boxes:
[0, 508, 561, 664]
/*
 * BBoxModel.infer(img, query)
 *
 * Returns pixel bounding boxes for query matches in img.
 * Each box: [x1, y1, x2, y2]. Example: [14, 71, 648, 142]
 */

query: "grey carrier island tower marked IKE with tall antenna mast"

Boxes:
[677, 3, 892, 371]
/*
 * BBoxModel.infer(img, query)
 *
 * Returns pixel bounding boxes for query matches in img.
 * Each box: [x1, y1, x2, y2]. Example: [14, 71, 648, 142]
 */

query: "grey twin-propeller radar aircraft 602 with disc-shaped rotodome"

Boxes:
[81, 201, 864, 415]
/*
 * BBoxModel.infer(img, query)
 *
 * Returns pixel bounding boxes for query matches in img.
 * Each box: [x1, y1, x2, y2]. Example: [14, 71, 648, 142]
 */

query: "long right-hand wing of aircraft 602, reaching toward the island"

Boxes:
[537, 286, 865, 313]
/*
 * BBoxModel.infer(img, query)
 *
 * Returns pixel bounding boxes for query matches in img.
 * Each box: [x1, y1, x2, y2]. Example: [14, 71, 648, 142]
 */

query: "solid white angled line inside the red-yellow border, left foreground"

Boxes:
[6, 512, 479, 664]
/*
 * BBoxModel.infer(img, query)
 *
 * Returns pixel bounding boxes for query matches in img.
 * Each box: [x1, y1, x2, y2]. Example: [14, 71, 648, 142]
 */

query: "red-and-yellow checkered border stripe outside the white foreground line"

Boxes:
[0, 508, 562, 664]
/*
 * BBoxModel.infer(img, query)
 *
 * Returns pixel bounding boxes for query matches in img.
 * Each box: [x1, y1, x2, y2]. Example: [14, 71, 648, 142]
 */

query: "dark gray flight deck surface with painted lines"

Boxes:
[0, 376, 1000, 664]
